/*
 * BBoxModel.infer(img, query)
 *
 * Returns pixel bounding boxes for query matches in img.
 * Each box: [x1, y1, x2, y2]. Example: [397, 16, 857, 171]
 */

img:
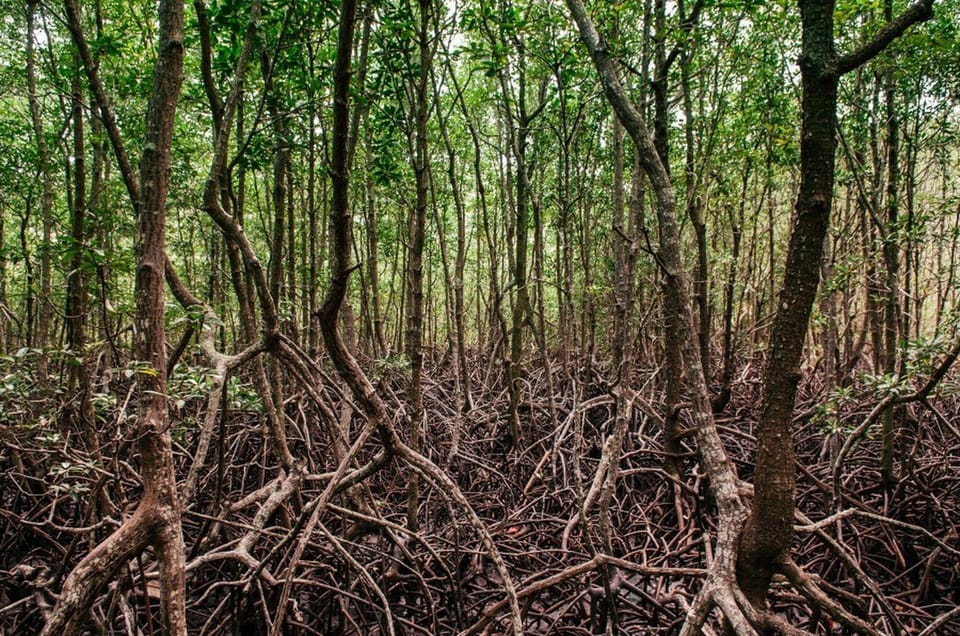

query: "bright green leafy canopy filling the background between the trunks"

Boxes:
[0, 0, 960, 400]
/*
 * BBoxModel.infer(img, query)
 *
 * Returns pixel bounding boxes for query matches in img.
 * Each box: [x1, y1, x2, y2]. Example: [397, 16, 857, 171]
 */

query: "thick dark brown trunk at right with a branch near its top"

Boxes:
[737, 0, 933, 607]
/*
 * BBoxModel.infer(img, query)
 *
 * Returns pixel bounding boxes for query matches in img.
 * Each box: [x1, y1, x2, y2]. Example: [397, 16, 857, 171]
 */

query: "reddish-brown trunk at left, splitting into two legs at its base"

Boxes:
[43, 0, 186, 635]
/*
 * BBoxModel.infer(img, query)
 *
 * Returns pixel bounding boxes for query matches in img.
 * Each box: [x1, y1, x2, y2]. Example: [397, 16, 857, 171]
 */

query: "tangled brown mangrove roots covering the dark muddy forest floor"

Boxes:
[0, 353, 960, 634]
